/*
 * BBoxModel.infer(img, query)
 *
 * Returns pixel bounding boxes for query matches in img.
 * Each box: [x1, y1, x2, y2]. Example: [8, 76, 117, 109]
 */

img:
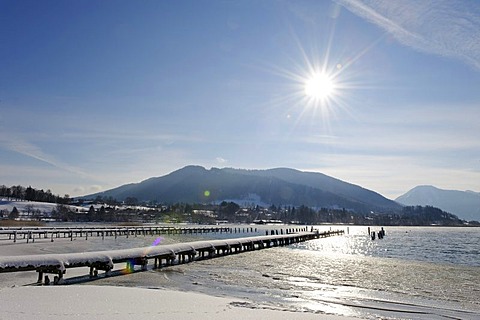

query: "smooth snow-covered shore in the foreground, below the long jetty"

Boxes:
[0, 285, 354, 320]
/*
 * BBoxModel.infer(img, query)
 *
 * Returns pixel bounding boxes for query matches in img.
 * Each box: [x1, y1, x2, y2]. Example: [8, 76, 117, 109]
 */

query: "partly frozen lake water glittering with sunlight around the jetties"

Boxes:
[0, 226, 480, 319]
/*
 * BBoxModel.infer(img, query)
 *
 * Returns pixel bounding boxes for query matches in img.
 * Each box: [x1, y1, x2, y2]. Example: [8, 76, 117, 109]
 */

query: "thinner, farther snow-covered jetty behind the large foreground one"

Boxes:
[0, 226, 232, 243]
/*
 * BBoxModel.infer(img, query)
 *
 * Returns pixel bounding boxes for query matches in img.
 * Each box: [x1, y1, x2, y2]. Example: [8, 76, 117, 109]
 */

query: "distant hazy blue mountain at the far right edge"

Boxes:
[396, 186, 480, 221]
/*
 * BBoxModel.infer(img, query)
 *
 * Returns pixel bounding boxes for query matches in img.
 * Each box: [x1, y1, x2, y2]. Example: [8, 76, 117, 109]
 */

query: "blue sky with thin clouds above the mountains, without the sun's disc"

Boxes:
[0, 0, 480, 198]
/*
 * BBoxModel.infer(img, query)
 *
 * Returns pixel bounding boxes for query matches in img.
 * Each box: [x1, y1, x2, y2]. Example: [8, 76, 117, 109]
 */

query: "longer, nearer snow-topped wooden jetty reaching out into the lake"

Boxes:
[0, 230, 344, 284]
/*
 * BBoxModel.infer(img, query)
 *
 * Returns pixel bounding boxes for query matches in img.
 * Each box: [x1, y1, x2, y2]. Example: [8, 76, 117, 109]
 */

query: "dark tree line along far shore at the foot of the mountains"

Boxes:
[0, 185, 479, 226]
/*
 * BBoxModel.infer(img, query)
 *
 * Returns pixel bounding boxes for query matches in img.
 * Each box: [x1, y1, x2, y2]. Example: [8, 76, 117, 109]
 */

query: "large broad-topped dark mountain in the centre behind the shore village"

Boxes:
[81, 166, 401, 213]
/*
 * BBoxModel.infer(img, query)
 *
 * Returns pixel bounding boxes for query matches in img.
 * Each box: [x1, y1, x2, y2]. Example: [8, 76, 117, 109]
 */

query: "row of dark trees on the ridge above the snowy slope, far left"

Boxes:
[0, 185, 71, 204]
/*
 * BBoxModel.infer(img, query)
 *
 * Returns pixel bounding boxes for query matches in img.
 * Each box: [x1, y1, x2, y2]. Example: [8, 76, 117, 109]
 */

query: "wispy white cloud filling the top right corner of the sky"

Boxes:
[337, 0, 480, 70]
